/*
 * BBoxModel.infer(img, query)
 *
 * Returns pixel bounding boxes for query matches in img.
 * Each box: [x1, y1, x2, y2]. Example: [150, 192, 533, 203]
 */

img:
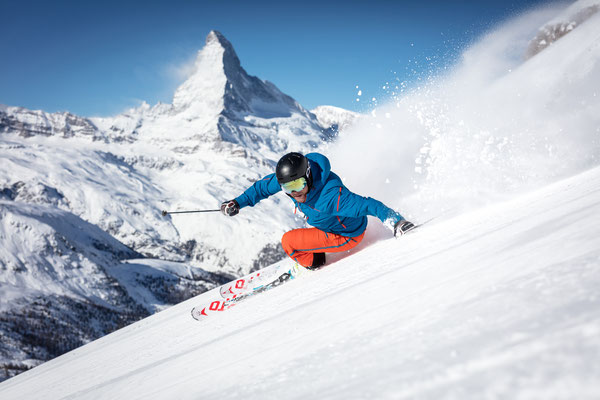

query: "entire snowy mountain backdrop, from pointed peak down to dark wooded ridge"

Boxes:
[0, 31, 356, 375]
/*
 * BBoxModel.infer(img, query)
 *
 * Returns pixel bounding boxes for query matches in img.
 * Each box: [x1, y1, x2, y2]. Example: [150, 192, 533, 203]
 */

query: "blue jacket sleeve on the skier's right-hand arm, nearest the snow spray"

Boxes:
[323, 186, 404, 226]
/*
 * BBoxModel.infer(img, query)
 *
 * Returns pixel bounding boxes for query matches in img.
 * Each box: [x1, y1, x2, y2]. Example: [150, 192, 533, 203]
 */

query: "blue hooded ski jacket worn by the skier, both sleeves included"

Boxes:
[235, 153, 403, 237]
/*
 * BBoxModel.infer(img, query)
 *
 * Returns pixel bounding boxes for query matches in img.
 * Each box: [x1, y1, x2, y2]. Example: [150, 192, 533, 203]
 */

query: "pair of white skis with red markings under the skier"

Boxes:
[191, 264, 308, 321]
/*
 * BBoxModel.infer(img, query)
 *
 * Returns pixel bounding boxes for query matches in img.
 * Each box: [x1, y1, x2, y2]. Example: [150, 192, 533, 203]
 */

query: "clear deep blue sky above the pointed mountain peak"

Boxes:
[0, 0, 546, 116]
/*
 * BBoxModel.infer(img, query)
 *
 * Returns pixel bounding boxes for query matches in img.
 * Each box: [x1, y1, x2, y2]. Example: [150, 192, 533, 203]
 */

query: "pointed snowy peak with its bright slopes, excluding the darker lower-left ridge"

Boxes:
[0, 31, 352, 272]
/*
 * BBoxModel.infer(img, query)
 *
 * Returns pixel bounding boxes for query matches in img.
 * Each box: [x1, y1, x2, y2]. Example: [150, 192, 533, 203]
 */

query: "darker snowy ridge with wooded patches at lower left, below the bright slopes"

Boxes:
[0, 200, 227, 378]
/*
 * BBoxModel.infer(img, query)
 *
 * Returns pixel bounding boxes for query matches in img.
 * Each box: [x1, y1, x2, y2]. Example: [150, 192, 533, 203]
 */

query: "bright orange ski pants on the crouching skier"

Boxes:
[281, 228, 365, 267]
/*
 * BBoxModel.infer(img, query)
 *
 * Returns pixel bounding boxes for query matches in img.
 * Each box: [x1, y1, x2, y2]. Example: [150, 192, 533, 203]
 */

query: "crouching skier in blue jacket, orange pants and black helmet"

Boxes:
[221, 153, 415, 269]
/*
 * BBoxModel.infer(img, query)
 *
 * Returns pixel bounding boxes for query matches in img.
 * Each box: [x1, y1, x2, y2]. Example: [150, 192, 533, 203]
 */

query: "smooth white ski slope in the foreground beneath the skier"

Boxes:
[0, 161, 600, 400]
